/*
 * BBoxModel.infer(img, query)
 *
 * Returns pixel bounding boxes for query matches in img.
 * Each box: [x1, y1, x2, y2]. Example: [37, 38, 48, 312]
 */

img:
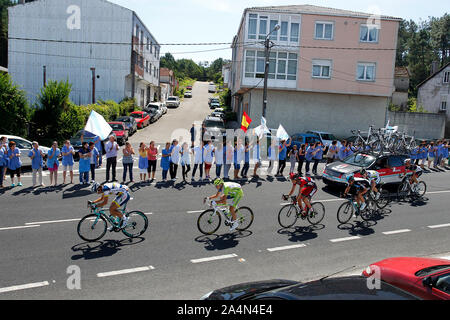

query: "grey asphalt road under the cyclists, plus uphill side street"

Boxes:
[0, 83, 450, 300]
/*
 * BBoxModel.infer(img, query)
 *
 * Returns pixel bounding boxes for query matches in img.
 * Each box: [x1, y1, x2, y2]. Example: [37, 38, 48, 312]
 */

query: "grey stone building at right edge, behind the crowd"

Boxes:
[417, 62, 450, 137]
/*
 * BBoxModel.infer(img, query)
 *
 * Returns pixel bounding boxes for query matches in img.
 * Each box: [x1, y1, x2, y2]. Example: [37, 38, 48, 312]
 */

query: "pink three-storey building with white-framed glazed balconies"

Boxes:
[231, 5, 401, 137]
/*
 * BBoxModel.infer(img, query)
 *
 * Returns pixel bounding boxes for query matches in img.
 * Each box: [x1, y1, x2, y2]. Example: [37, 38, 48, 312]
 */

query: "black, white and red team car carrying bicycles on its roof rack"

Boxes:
[322, 153, 407, 186]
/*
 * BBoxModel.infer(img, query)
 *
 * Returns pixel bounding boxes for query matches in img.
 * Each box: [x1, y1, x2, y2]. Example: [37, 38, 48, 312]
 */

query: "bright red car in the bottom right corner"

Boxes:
[362, 257, 450, 300]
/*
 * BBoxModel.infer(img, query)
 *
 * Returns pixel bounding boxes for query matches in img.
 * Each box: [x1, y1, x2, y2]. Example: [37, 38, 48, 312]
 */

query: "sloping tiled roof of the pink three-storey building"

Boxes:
[246, 4, 403, 21]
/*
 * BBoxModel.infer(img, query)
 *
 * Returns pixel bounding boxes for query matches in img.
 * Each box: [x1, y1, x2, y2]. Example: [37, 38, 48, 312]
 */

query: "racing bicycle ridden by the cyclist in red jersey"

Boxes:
[278, 195, 325, 228]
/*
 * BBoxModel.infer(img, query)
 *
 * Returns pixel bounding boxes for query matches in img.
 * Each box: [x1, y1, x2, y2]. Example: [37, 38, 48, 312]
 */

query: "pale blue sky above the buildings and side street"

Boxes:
[109, 0, 450, 63]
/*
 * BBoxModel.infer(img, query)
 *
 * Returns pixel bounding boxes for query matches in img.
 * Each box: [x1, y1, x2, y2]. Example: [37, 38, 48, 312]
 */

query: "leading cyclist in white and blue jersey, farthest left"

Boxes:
[90, 181, 130, 231]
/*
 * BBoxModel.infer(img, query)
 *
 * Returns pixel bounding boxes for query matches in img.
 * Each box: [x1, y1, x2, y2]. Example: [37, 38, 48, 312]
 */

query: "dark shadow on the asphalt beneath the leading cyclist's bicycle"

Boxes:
[71, 238, 145, 260]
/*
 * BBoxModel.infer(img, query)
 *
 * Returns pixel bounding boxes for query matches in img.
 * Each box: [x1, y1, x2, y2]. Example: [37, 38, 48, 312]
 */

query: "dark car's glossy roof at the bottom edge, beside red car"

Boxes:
[202, 276, 419, 300]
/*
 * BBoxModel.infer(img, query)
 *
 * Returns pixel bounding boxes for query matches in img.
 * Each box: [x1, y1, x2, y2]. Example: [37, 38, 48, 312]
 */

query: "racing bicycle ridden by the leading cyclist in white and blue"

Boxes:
[77, 201, 148, 242]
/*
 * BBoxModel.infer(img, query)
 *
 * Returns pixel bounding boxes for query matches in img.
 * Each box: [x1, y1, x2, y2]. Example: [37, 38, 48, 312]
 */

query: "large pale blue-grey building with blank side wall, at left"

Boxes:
[8, 0, 160, 106]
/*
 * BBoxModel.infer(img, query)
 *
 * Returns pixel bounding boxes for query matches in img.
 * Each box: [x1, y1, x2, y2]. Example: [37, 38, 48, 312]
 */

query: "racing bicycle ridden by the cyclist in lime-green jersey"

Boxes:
[197, 200, 254, 235]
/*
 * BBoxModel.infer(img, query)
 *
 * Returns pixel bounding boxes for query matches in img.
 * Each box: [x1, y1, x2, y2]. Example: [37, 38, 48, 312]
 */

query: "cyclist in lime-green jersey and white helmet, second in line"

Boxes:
[203, 178, 244, 231]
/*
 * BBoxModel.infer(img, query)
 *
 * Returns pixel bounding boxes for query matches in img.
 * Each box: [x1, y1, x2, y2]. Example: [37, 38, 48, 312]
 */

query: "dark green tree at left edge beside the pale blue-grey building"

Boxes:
[0, 74, 31, 137]
